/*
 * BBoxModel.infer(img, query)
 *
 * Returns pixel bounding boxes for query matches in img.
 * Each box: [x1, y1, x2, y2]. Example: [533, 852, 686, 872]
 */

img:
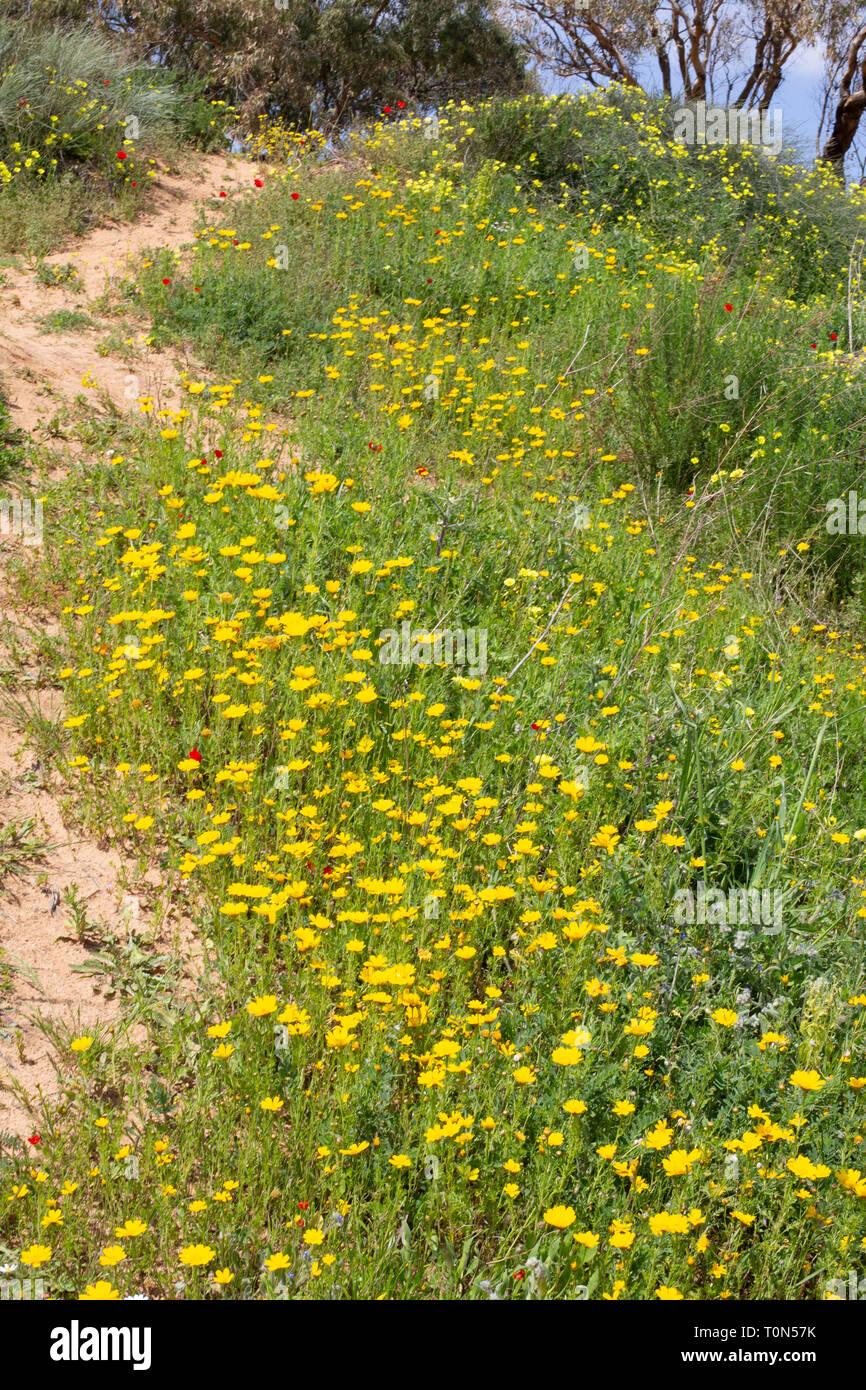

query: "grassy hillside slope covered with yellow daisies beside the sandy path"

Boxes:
[3, 86, 866, 1300]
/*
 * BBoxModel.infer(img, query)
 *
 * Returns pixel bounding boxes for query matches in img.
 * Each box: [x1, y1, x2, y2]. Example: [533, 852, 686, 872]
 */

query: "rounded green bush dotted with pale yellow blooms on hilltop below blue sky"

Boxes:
[459, 88, 863, 299]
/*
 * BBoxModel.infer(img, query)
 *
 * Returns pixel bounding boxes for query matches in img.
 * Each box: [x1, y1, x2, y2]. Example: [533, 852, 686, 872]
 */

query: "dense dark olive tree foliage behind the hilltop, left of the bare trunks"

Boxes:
[4, 0, 527, 128]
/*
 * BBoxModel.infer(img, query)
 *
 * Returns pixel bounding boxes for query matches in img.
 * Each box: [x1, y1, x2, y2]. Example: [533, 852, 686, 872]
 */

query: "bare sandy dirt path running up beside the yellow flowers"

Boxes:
[0, 156, 253, 1147]
